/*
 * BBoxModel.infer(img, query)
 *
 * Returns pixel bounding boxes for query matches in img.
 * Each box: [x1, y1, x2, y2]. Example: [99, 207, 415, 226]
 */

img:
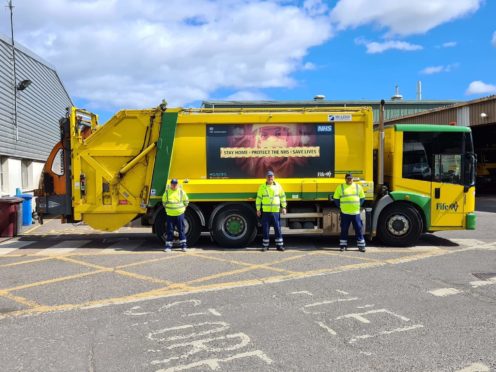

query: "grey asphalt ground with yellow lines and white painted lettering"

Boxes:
[0, 196, 496, 372]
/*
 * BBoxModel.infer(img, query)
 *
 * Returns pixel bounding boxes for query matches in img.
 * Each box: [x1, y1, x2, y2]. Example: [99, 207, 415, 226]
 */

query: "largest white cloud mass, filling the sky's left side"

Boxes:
[0, 0, 332, 110]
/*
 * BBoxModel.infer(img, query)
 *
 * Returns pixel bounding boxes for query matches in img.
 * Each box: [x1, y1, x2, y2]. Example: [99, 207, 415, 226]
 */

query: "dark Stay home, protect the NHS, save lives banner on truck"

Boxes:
[203, 123, 334, 179]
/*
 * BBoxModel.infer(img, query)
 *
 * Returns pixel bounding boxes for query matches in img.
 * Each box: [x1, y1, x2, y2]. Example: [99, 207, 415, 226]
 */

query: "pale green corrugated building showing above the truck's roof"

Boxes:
[202, 100, 459, 123]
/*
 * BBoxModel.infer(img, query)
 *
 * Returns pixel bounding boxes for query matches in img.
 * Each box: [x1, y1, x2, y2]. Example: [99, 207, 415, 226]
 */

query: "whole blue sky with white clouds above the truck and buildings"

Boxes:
[0, 0, 496, 121]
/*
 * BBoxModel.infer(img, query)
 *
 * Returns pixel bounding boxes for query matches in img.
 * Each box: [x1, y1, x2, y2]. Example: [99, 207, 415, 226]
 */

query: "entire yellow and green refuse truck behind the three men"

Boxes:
[36, 104, 475, 247]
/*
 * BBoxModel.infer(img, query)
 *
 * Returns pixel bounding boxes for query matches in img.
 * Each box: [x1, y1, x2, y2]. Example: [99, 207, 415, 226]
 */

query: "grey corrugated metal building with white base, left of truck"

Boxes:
[0, 35, 72, 196]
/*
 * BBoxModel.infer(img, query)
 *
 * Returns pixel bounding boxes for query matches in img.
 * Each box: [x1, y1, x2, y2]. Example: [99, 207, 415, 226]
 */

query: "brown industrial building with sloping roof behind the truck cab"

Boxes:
[386, 95, 496, 192]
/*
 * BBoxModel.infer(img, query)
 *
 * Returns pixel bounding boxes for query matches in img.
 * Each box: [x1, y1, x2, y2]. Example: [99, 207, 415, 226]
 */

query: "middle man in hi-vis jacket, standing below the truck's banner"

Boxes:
[256, 171, 286, 252]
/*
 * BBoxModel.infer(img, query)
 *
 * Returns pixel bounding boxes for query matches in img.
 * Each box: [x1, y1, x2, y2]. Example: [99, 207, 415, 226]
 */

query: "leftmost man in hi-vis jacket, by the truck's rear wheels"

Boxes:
[162, 178, 189, 252]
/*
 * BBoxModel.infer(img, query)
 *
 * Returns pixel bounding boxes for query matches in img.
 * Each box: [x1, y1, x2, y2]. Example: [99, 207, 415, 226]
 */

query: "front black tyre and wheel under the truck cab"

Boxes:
[377, 203, 423, 247]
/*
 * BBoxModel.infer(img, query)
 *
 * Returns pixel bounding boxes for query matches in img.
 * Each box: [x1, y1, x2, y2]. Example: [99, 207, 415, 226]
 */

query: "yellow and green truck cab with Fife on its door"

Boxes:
[374, 124, 476, 245]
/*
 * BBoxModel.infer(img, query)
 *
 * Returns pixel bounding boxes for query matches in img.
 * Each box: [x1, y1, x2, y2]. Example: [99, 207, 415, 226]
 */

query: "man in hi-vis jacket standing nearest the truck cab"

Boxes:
[333, 173, 365, 252]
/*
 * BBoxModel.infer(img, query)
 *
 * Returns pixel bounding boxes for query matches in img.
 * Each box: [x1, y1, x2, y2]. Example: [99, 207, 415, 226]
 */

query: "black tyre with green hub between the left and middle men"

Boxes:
[211, 204, 257, 248]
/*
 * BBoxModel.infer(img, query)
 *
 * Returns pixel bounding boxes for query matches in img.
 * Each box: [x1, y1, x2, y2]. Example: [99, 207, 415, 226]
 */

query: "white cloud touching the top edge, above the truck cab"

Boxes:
[331, 0, 484, 36]
